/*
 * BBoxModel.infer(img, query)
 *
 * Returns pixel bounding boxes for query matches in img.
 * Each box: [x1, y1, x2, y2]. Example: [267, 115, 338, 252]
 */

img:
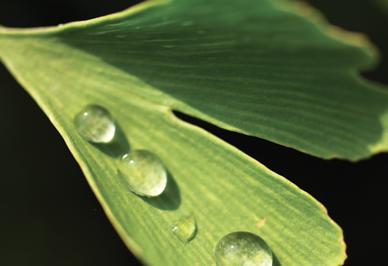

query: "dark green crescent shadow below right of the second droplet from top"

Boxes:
[142, 171, 181, 211]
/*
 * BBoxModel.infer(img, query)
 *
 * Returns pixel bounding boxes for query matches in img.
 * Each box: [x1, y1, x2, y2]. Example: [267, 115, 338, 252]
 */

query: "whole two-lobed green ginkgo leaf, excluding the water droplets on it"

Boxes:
[0, 0, 388, 266]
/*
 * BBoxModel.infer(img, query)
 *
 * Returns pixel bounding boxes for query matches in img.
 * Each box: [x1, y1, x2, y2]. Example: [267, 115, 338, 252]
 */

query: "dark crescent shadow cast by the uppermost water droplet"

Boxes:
[92, 122, 130, 158]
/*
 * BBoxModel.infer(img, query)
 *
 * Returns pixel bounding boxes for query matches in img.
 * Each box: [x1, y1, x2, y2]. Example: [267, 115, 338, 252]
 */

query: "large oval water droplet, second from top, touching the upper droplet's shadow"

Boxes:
[119, 150, 167, 197]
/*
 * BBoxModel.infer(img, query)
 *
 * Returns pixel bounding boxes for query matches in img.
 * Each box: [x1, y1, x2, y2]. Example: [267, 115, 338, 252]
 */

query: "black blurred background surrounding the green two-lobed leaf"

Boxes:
[0, 0, 388, 266]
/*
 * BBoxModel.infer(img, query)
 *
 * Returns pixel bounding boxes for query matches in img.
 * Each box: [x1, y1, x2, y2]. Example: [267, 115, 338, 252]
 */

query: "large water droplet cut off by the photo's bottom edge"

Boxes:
[215, 232, 272, 266]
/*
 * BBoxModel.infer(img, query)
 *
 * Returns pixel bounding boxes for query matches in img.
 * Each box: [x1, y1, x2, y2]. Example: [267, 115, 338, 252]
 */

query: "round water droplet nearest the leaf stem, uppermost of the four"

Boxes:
[74, 105, 116, 143]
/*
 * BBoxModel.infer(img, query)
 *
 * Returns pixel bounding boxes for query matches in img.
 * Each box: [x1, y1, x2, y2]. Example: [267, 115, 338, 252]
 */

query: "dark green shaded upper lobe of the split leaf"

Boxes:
[3, 0, 388, 160]
